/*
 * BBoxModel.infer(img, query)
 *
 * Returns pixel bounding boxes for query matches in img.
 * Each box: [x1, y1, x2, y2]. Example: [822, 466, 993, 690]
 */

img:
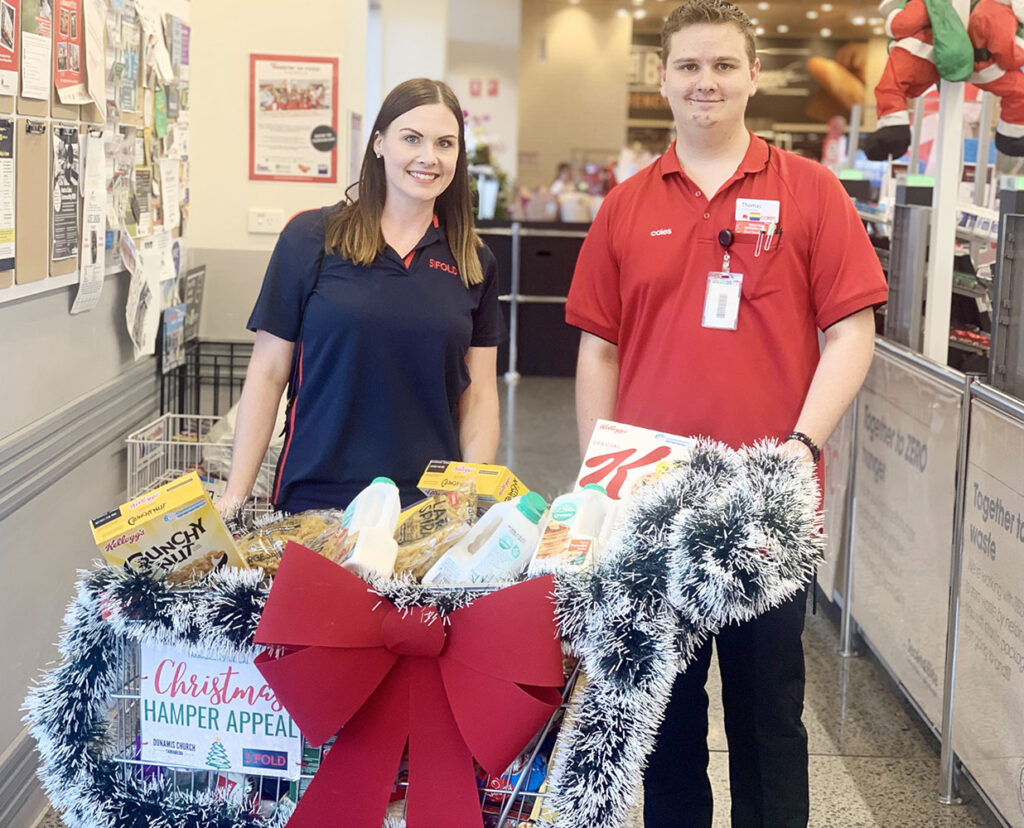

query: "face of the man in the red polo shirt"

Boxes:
[662, 24, 761, 132]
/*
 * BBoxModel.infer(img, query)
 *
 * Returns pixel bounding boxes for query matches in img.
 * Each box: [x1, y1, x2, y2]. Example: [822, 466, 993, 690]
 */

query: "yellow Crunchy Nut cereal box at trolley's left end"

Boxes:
[91, 472, 246, 578]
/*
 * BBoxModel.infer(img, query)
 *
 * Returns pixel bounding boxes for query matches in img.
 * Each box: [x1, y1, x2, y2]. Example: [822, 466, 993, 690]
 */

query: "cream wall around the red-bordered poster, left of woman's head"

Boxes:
[188, 0, 367, 253]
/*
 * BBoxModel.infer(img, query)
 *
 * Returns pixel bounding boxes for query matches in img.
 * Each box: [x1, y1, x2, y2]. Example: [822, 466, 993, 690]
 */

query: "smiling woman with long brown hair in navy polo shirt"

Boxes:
[218, 79, 504, 514]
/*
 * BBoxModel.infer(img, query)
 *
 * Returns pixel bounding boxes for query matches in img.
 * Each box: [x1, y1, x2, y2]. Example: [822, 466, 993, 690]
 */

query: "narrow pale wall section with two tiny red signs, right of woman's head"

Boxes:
[444, 0, 521, 180]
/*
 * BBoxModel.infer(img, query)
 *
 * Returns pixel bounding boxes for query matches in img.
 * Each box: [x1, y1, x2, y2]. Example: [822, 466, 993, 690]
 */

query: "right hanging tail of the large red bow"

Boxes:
[406, 658, 483, 828]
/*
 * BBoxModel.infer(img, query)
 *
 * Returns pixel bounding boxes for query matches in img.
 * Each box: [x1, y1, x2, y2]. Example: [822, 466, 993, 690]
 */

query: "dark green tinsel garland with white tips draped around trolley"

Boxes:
[25, 442, 821, 828]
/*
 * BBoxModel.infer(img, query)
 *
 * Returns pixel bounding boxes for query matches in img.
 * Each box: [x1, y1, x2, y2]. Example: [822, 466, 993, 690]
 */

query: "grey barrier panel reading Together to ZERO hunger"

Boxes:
[852, 353, 962, 725]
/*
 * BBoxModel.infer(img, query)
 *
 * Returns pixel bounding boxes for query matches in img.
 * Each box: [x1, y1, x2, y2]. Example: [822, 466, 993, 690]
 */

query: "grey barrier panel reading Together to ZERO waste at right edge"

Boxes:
[951, 402, 1024, 826]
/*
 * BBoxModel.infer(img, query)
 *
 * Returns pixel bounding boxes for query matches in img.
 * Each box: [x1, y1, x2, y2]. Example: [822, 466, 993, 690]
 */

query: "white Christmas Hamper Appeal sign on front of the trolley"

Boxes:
[139, 644, 302, 779]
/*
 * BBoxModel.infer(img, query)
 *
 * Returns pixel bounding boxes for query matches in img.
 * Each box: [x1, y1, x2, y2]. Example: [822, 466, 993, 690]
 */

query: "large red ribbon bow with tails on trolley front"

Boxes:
[255, 542, 563, 828]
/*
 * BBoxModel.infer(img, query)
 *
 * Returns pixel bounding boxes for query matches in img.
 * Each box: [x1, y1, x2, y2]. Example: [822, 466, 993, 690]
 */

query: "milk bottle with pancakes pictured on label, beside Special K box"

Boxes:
[528, 483, 615, 575]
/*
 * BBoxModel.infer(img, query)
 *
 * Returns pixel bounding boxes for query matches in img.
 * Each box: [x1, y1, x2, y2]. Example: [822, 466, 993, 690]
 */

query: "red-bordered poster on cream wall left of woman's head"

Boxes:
[249, 54, 338, 184]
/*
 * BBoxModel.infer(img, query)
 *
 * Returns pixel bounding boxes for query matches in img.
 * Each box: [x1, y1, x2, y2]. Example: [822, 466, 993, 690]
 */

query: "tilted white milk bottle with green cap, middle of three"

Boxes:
[423, 491, 548, 583]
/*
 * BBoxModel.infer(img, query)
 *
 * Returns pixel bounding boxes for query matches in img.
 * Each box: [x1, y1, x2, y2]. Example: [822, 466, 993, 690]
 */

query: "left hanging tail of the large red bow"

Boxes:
[288, 659, 410, 828]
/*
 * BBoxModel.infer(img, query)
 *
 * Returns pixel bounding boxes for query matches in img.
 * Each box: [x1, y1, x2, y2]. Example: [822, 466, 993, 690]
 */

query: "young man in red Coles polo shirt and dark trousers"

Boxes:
[565, 0, 886, 828]
